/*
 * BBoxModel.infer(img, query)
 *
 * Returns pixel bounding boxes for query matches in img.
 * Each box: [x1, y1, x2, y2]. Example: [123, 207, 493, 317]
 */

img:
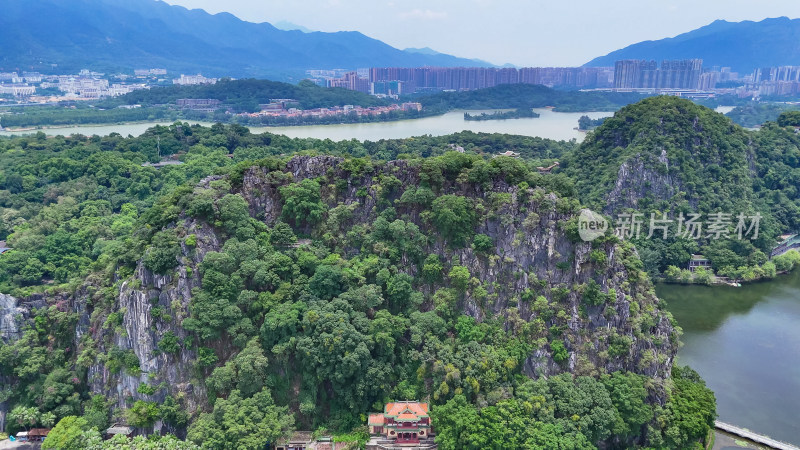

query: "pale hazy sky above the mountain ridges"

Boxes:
[162, 0, 800, 66]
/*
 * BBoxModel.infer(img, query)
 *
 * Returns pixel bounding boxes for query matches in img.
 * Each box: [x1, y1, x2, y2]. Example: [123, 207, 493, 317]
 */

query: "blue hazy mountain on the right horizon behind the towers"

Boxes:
[585, 17, 800, 73]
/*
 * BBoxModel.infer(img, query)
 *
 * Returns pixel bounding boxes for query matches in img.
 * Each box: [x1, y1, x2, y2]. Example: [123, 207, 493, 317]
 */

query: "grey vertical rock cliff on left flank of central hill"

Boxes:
[88, 220, 220, 427]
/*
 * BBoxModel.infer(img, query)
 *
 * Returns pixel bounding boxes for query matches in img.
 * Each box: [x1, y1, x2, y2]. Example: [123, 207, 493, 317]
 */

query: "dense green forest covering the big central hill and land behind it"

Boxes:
[0, 115, 715, 449]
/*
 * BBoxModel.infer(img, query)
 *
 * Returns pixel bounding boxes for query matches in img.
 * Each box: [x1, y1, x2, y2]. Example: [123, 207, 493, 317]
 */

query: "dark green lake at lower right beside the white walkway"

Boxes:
[656, 270, 800, 445]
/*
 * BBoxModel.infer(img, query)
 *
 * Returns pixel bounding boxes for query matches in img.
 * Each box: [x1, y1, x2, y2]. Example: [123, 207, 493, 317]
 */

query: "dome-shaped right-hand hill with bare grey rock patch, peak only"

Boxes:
[564, 97, 756, 214]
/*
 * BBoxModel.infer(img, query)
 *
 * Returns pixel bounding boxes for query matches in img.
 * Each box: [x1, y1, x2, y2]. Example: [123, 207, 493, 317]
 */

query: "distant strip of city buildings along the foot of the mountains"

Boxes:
[0, 59, 800, 106]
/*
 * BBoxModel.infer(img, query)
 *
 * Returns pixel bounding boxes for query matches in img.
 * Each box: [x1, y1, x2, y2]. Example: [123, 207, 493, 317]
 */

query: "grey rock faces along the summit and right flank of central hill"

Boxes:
[238, 157, 677, 378]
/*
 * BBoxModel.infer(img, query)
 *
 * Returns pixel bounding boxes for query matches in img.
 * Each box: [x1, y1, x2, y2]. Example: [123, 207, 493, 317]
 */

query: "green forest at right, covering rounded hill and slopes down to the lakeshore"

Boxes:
[561, 97, 800, 282]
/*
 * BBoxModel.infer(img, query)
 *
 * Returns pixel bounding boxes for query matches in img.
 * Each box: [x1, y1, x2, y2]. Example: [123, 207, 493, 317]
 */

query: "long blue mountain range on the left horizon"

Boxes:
[0, 0, 491, 79]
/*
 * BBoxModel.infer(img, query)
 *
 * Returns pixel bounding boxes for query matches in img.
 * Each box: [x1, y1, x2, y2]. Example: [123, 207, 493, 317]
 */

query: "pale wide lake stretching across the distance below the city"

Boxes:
[0, 108, 613, 141]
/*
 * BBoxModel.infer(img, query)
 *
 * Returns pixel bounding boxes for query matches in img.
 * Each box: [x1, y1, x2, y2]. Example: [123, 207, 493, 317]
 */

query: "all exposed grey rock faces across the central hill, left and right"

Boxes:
[7, 156, 677, 422]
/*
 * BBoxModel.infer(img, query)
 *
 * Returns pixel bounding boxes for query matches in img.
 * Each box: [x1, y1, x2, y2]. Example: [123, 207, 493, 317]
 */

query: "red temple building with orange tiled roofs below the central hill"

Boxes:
[368, 402, 433, 444]
